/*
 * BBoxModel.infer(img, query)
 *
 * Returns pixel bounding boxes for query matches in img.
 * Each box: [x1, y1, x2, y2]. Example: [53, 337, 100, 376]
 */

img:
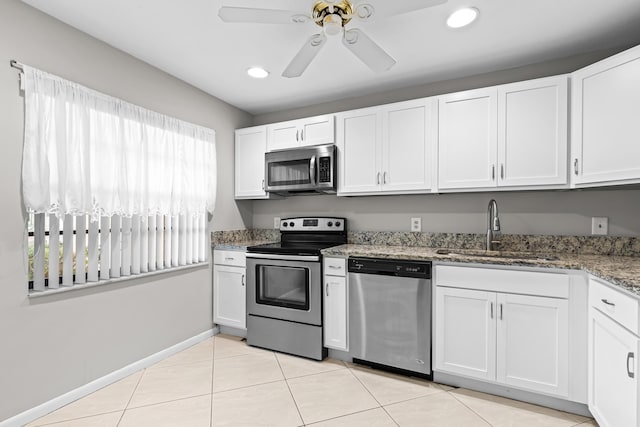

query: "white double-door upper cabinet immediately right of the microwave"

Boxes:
[336, 98, 436, 195]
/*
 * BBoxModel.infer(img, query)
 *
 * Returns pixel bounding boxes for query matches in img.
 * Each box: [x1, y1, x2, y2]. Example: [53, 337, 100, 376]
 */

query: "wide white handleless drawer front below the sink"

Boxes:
[434, 265, 570, 299]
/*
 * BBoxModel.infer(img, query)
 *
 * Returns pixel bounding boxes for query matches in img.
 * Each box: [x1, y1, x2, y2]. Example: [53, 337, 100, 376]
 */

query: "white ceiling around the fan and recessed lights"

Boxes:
[23, 0, 640, 114]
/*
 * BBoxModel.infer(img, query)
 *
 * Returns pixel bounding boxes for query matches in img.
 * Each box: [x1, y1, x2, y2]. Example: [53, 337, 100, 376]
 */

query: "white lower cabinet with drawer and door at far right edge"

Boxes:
[588, 280, 640, 427]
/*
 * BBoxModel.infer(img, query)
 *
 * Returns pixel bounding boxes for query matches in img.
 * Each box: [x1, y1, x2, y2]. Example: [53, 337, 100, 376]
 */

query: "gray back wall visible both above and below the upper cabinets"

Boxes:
[253, 48, 640, 236]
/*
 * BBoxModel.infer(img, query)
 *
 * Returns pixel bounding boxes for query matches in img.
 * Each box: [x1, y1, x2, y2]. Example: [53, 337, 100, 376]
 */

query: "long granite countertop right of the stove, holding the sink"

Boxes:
[322, 244, 640, 298]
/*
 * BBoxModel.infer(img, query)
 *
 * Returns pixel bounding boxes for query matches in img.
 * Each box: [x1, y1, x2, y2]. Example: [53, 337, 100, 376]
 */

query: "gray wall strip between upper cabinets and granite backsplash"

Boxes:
[253, 190, 640, 236]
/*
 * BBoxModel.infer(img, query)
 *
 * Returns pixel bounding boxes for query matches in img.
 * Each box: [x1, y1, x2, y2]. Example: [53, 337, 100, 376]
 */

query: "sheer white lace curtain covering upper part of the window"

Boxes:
[22, 66, 216, 224]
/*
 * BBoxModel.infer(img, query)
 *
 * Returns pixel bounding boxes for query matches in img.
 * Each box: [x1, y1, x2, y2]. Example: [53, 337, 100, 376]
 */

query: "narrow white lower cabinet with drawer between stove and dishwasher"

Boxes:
[323, 258, 349, 351]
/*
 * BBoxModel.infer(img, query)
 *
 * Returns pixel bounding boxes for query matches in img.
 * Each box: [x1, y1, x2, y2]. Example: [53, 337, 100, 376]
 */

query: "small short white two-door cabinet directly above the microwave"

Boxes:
[267, 115, 335, 151]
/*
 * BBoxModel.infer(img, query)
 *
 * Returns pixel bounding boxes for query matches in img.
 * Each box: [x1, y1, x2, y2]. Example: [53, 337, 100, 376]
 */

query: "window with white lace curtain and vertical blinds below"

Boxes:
[23, 66, 216, 291]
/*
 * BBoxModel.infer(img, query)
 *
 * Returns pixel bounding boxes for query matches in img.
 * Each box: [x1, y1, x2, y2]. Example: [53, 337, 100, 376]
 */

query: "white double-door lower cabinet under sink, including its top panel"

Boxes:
[434, 267, 569, 397]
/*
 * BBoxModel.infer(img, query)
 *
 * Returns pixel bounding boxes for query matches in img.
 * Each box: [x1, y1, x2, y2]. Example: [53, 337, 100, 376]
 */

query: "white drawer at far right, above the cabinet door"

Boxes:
[589, 277, 639, 335]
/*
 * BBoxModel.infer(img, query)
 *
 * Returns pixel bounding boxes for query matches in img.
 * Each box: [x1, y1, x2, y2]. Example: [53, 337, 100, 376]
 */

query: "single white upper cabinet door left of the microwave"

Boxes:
[235, 126, 268, 199]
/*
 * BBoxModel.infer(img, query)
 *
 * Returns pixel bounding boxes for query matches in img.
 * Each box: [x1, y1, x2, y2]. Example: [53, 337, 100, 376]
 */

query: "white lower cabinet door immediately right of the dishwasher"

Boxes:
[434, 286, 496, 381]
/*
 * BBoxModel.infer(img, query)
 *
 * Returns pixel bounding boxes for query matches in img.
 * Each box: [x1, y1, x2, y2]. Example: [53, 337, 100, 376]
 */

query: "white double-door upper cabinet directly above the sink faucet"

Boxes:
[438, 76, 568, 190]
